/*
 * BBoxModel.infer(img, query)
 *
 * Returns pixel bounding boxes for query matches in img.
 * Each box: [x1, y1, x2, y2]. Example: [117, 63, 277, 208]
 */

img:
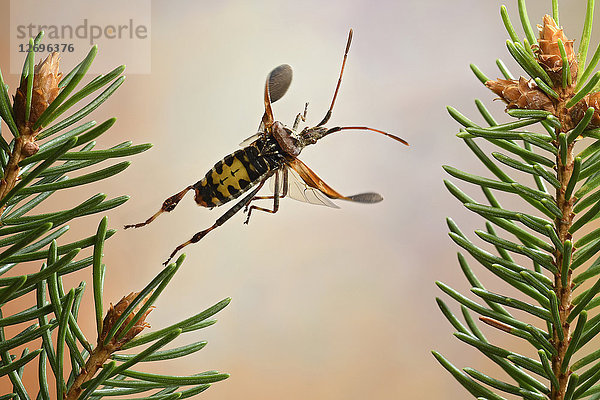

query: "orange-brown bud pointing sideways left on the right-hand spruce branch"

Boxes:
[485, 77, 554, 113]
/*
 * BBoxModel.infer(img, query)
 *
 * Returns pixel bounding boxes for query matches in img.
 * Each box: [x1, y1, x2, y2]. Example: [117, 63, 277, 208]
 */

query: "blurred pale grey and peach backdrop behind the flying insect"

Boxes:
[0, 0, 598, 400]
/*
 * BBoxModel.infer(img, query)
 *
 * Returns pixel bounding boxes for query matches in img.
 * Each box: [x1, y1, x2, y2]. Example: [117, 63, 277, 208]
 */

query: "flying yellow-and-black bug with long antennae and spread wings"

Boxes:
[125, 29, 408, 265]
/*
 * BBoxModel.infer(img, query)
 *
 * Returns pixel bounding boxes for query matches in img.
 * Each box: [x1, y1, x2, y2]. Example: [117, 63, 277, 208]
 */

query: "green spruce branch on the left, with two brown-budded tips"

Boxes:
[0, 32, 230, 400]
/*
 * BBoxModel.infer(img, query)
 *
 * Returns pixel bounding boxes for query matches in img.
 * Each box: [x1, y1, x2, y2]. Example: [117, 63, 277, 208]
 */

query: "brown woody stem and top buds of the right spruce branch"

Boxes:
[483, 15, 600, 400]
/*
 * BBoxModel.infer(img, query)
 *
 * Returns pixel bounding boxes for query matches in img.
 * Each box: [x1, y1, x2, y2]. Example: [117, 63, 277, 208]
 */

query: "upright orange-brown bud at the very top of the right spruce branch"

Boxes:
[536, 14, 577, 86]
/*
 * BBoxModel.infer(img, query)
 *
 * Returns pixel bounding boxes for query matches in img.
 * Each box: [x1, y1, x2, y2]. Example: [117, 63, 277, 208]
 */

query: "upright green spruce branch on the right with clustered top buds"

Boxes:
[434, 0, 600, 400]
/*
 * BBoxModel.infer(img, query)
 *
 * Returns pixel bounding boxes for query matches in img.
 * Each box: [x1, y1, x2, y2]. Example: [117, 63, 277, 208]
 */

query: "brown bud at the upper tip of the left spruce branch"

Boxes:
[13, 52, 62, 131]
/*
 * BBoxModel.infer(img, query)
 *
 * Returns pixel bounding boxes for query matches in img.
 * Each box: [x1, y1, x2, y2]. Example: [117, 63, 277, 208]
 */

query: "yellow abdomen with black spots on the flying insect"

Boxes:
[194, 146, 279, 207]
